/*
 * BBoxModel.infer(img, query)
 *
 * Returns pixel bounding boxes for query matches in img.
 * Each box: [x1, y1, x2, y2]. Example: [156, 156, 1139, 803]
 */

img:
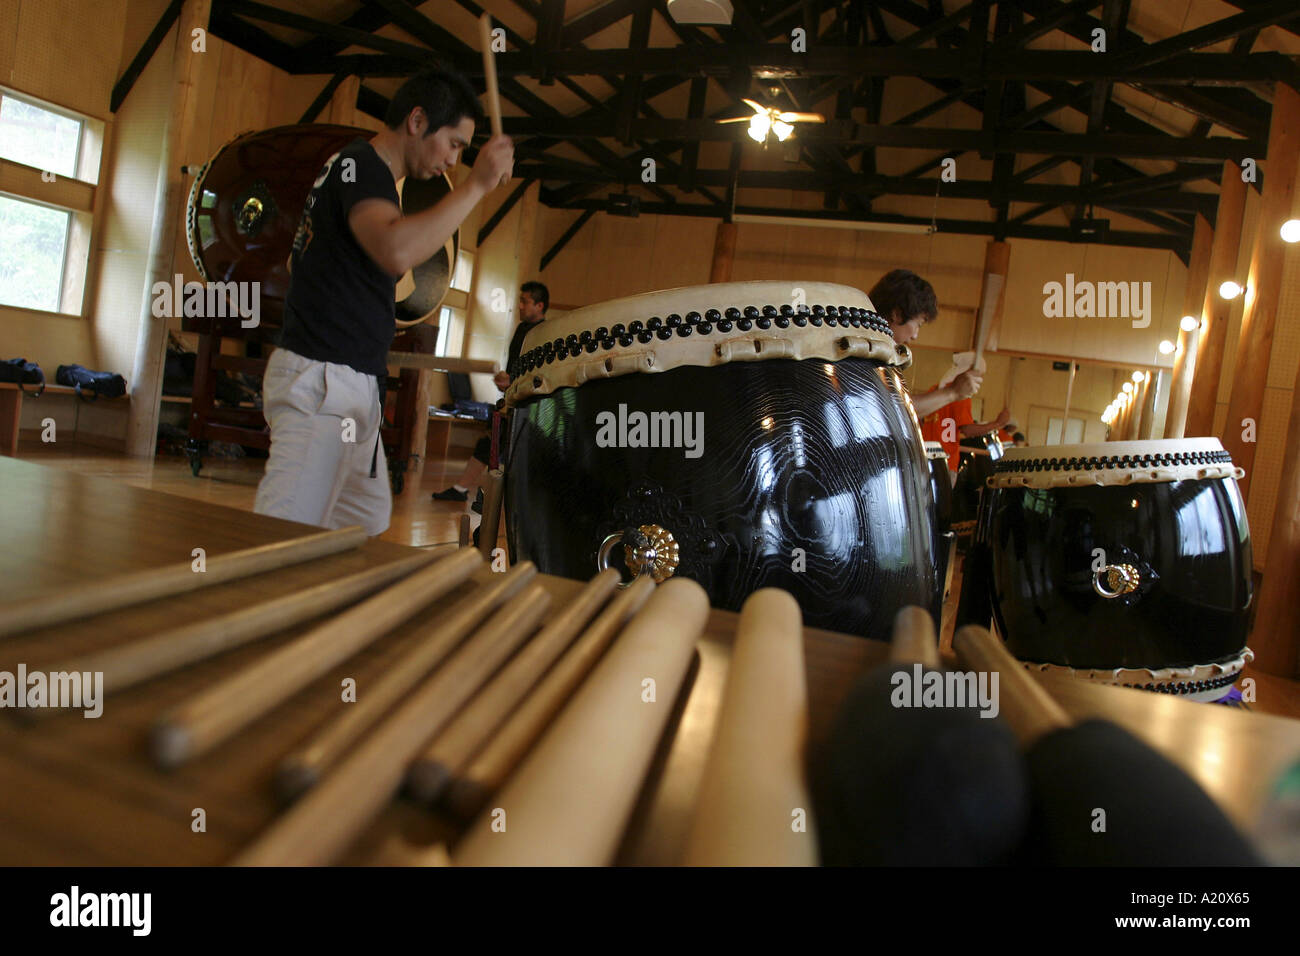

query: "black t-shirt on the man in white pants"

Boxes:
[280, 139, 400, 377]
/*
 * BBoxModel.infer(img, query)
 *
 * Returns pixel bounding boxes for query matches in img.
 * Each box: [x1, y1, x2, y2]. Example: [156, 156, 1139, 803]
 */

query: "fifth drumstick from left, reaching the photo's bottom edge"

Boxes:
[233, 584, 551, 866]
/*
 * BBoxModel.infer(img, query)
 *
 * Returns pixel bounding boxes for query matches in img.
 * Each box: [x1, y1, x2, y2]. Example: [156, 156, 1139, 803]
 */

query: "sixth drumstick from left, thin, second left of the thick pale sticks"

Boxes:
[407, 568, 624, 801]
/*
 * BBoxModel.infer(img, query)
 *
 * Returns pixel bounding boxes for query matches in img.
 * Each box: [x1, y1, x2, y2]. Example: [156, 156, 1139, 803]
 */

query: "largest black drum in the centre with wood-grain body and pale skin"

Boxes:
[506, 282, 935, 637]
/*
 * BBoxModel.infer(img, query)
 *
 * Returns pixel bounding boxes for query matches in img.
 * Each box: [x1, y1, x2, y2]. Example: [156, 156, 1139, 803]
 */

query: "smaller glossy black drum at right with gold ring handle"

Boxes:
[963, 438, 1252, 700]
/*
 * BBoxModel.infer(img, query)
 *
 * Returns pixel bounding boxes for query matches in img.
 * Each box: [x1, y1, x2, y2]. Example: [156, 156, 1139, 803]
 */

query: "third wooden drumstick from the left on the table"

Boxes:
[152, 549, 482, 767]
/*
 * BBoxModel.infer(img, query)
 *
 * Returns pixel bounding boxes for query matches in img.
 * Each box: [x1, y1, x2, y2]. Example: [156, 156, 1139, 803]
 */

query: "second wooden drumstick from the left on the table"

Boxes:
[39, 550, 441, 697]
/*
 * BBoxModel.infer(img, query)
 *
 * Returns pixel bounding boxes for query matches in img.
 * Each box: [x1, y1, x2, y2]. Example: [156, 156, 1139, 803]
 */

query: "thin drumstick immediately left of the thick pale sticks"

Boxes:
[439, 576, 655, 819]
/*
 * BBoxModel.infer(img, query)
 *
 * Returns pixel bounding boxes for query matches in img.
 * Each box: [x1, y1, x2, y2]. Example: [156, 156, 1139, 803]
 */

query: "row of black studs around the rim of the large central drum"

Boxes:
[520, 304, 891, 375]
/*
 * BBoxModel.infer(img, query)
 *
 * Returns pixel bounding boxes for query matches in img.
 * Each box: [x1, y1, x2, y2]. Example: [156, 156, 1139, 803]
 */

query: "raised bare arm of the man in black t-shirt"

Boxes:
[347, 137, 515, 276]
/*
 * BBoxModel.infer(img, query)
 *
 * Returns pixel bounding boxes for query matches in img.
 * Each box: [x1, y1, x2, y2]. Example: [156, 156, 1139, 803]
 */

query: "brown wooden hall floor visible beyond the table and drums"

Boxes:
[10, 441, 1300, 719]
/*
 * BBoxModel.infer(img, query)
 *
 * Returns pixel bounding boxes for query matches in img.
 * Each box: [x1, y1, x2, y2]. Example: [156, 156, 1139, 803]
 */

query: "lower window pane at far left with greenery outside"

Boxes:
[0, 195, 72, 312]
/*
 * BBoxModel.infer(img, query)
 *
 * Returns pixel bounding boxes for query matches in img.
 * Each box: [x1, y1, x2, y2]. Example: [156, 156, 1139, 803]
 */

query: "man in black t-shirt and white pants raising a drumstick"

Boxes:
[254, 70, 515, 535]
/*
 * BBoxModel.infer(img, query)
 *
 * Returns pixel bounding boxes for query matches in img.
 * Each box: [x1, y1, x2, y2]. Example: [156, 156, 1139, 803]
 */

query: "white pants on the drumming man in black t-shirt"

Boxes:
[254, 349, 393, 535]
